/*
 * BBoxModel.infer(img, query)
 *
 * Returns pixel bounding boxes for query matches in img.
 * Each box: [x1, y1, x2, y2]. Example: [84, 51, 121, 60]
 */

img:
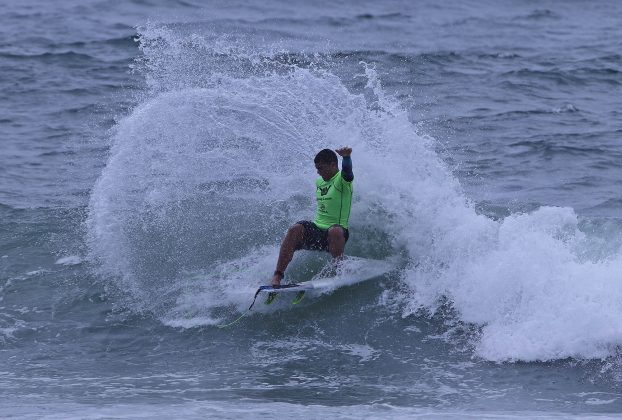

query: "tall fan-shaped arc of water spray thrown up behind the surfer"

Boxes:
[89, 24, 444, 313]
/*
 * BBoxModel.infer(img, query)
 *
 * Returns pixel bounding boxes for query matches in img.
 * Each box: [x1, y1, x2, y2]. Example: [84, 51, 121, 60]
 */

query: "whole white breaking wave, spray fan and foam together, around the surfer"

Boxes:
[88, 25, 622, 361]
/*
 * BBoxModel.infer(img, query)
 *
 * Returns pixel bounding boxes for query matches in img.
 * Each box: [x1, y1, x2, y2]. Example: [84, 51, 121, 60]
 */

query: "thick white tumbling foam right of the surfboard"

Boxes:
[405, 208, 622, 361]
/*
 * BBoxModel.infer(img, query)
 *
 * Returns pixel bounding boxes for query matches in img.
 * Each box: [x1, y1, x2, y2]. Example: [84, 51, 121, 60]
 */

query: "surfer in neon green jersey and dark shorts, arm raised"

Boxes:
[272, 147, 354, 286]
